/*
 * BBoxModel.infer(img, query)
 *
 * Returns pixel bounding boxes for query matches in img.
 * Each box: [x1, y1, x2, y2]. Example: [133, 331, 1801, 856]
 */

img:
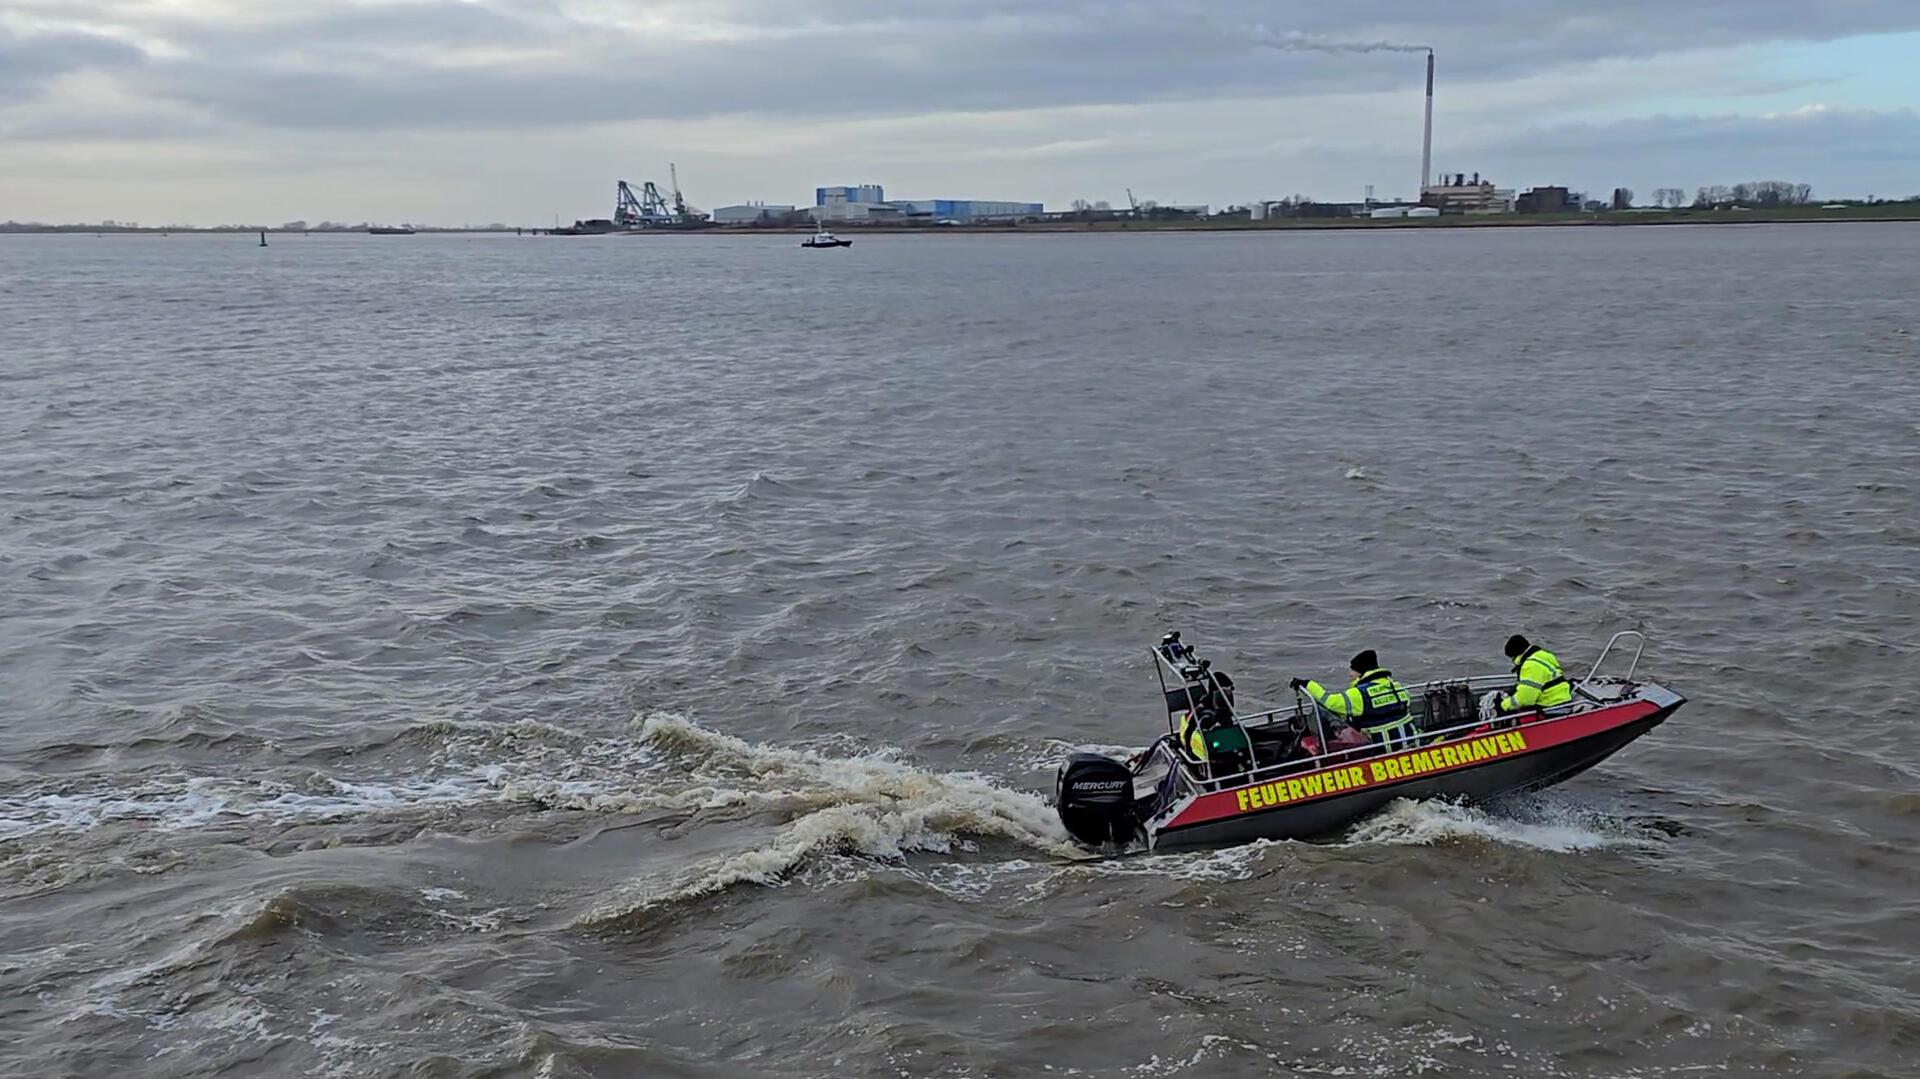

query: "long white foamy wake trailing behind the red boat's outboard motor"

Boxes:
[0, 712, 1081, 931]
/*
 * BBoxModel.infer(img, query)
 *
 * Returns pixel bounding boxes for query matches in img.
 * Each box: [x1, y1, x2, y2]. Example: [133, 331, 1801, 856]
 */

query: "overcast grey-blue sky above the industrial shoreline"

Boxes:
[0, 0, 1920, 225]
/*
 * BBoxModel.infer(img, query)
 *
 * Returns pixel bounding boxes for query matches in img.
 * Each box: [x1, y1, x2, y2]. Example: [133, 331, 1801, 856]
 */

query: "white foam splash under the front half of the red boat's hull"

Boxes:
[1342, 799, 1645, 854]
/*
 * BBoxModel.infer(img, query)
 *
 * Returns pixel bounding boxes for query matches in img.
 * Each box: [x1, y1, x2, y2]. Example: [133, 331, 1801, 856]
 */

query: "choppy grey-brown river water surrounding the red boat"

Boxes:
[11, 225, 1920, 1077]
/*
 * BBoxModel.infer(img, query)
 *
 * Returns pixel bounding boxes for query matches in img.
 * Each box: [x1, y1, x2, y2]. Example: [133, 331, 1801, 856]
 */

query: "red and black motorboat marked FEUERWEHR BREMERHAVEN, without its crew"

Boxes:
[1054, 630, 1686, 851]
